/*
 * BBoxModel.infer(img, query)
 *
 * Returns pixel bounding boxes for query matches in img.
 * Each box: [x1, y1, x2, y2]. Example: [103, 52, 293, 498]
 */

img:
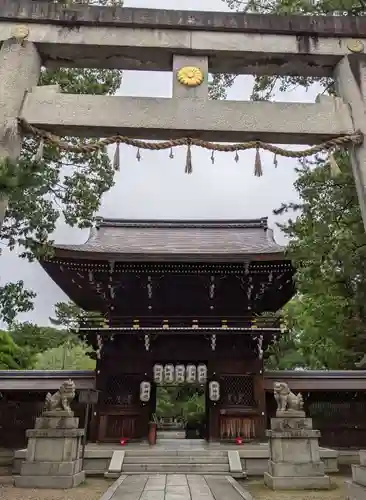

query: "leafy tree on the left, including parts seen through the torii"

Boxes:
[0, 0, 122, 322]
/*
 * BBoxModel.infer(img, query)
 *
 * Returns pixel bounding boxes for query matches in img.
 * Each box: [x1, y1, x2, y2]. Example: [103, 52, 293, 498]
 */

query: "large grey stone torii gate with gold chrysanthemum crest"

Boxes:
[0, 0, 366, 227]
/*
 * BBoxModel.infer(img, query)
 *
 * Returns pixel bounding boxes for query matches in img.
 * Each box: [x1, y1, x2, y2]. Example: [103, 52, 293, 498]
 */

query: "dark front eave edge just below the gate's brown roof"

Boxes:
[49, 246, 289, 263]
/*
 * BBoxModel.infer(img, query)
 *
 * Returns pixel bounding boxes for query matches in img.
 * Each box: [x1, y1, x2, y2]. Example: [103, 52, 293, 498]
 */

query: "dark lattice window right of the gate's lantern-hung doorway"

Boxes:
[220, 375, 256, 407]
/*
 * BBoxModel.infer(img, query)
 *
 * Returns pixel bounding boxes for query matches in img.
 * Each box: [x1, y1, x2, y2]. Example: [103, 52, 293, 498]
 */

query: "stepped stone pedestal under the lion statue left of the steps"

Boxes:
[15, 411, 85, 489]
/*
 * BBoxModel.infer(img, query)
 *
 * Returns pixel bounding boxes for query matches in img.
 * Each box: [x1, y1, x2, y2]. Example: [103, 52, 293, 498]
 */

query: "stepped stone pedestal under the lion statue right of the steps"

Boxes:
[264, 411, 331, 490]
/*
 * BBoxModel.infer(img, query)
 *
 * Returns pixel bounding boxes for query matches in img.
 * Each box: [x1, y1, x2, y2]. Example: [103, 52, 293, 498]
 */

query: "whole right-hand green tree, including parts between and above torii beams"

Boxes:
[225, 0, 366, 369]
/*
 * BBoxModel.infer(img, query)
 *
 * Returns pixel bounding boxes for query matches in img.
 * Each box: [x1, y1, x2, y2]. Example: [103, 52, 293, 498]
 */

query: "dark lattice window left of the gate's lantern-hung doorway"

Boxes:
[102, 374, 140, 406]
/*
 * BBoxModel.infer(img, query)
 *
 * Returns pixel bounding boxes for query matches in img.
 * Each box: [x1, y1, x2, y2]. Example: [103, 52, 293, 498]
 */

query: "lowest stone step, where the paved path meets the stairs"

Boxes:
[122, 463, 230, 474]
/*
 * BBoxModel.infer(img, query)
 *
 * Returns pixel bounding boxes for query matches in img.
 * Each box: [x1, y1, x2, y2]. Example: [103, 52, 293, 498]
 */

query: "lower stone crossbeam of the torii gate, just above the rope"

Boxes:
[21, 87, 354, 144]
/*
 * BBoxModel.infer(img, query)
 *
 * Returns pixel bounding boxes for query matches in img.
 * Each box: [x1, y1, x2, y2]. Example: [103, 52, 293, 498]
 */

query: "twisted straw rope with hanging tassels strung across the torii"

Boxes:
[19, 120, 363, 177]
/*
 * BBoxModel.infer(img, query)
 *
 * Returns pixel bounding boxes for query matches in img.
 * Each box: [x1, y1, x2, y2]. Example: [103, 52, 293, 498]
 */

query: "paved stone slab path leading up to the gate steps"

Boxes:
[101, 474, 252, 500]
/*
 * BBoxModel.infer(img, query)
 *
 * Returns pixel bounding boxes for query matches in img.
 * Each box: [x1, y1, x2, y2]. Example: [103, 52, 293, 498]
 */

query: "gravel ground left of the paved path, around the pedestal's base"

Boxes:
[0, 478, 113, 500]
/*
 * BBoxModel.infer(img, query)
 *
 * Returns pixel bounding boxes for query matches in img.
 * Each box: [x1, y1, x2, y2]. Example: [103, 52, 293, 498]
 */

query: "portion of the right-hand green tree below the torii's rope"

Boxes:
[276, 153, 366, 369]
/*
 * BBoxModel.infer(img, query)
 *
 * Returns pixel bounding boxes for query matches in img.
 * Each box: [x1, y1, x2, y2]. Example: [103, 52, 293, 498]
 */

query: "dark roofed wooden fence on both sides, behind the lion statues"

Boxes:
[0, 371, 366, 449]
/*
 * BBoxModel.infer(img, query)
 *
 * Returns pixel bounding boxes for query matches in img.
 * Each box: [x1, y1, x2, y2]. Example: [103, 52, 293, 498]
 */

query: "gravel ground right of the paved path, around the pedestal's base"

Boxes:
[242, 476, 349, 500]
